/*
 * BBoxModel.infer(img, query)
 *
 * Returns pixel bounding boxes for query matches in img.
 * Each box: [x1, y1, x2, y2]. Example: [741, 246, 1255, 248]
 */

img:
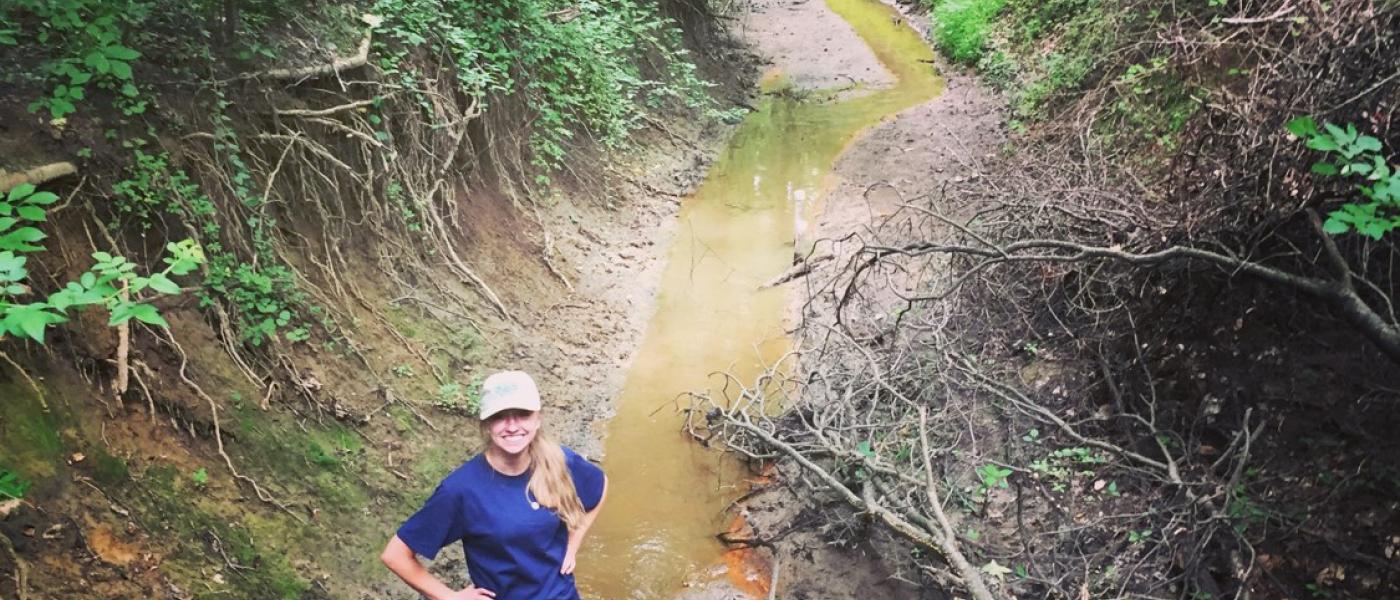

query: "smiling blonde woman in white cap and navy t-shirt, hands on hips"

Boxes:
[379, 371, 608, 600]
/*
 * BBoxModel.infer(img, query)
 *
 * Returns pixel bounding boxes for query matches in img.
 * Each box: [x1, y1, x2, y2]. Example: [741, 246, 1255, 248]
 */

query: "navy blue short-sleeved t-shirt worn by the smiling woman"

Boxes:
[399, 448, 603, 600]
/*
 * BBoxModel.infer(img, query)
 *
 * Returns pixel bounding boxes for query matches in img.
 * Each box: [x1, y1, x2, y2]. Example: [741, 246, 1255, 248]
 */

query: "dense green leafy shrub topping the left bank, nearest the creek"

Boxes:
[374, 0, 706, 180]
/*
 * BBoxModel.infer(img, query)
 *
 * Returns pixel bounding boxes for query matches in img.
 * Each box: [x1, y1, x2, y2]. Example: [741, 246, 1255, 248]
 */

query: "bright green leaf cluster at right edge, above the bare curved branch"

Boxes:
[1285, 116, 1400, 239]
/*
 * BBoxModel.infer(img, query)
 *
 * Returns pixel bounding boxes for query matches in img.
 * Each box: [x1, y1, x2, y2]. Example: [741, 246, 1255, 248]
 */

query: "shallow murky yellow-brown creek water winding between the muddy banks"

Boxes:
[578, 0, 942, 600]
